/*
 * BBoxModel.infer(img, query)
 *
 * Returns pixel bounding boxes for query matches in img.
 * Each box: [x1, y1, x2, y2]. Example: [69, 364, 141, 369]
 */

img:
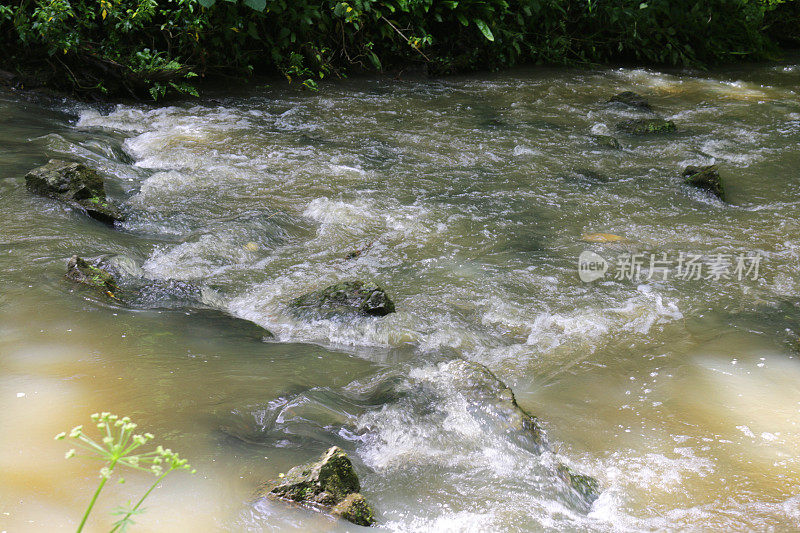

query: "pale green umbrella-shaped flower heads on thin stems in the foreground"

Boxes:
[56, 412, 194, 533]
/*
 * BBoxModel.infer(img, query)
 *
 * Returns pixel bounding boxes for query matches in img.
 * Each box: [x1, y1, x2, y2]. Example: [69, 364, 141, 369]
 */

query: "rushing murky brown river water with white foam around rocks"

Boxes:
[0, 63, 800, 532]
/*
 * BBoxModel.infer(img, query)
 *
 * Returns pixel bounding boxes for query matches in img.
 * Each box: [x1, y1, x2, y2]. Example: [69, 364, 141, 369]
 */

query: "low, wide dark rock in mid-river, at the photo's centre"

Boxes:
[290, 281, 394, 318]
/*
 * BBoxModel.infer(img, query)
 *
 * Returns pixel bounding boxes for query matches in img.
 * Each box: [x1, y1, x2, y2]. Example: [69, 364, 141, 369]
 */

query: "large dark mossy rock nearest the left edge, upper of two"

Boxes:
[25, 159, 124, 225]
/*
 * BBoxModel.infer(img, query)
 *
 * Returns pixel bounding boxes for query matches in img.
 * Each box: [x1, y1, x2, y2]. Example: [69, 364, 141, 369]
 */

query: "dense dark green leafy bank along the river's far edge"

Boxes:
[0, 0, 800, 99]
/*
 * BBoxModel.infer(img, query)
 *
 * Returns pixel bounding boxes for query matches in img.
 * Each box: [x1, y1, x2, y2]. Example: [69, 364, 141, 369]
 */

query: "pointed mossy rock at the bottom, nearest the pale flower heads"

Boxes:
[258, 446, 375, 526]
